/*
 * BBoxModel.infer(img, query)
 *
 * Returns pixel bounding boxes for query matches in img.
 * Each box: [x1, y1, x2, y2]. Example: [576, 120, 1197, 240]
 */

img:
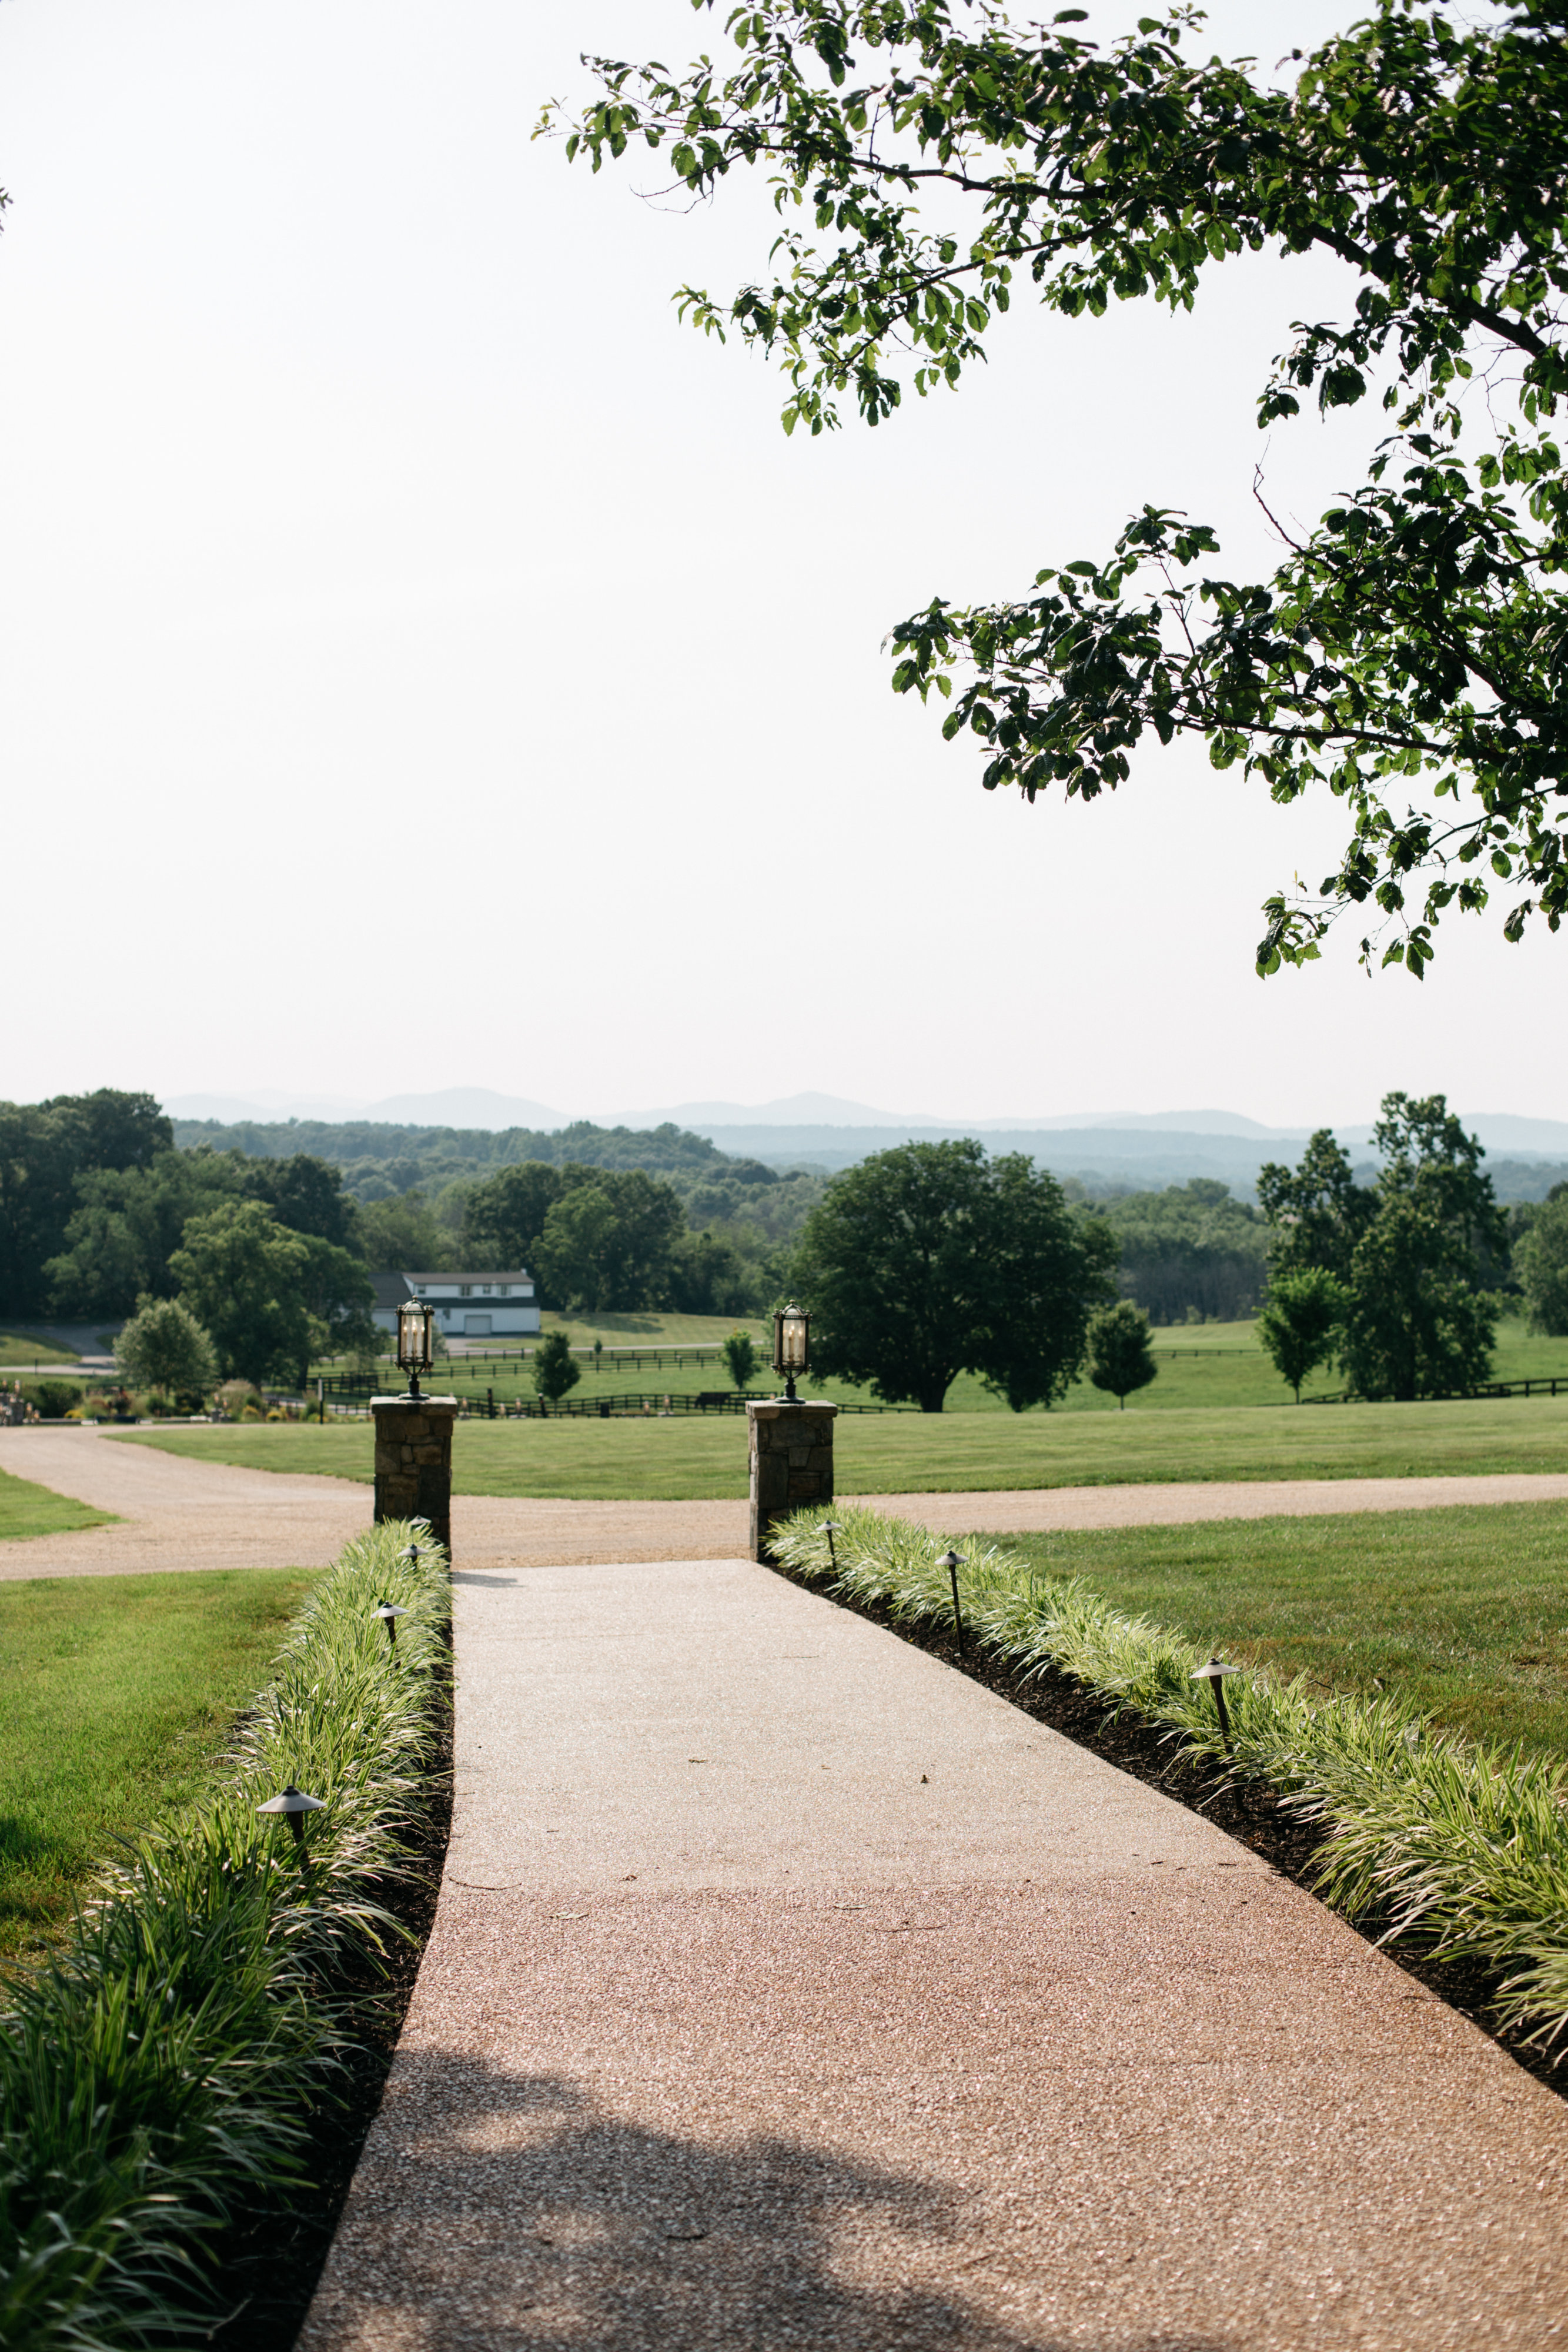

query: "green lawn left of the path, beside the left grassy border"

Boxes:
[0, 1569, 310, 1957]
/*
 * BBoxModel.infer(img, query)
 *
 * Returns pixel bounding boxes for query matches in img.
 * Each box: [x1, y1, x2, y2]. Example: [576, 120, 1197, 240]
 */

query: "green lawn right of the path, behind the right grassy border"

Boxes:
[1001, 1503, 1568, 1752]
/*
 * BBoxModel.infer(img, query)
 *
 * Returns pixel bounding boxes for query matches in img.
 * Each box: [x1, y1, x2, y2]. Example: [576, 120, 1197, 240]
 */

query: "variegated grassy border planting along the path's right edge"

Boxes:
[771, 1510, 1568, 2074]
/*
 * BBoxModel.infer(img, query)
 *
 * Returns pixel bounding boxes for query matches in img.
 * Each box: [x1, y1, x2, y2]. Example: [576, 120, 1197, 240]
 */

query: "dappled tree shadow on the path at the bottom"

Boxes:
[299, 2051, 1218, 2352]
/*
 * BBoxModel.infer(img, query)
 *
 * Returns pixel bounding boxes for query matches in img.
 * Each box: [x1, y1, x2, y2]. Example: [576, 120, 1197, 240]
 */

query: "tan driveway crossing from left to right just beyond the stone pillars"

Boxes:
[0, 1428, 1568, 1581]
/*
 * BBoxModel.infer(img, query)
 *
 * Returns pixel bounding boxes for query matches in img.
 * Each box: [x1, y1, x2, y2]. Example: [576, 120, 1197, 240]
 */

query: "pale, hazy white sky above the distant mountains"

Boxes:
[0, 0, 1568, 1124]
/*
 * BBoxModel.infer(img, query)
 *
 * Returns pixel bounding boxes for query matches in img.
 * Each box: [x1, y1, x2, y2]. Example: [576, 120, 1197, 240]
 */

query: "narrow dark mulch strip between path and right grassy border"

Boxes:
[771, 1562, 1568, 2098]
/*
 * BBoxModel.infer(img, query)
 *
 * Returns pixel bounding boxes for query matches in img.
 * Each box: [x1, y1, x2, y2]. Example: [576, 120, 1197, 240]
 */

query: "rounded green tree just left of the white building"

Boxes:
[169, 1200, 325, 1388]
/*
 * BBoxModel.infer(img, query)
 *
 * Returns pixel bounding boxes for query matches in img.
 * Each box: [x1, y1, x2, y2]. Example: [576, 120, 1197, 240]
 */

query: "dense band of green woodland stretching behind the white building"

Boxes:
[0, 1089, 1568, 1327]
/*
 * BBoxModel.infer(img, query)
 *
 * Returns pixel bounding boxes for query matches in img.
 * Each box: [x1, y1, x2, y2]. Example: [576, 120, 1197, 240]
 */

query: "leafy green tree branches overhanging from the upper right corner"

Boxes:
[554, 0, 1568, 976]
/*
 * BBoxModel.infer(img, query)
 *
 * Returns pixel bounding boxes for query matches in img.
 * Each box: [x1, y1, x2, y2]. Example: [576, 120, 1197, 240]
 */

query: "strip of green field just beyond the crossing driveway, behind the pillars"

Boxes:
[111, 1397, 1568, 1498]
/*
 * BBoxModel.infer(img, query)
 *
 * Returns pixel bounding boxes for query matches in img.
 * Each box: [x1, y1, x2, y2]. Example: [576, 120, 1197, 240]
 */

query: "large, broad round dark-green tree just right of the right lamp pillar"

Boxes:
[794, 1141, 1116, 1414]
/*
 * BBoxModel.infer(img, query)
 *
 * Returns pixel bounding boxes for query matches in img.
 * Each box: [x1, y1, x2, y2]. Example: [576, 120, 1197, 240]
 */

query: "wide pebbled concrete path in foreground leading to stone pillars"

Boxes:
[301, 1552, 1568, 2352]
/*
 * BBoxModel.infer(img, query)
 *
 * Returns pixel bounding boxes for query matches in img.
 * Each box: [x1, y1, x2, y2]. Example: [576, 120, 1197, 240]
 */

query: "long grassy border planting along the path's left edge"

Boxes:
[0, 1524, 452, 2352]
